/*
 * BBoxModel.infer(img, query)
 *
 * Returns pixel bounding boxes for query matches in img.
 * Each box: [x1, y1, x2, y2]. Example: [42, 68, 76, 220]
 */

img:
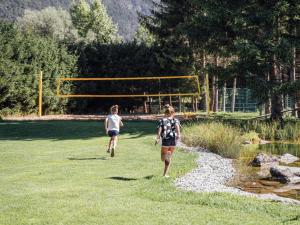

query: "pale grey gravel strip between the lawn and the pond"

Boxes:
[175, 143, 300, 205]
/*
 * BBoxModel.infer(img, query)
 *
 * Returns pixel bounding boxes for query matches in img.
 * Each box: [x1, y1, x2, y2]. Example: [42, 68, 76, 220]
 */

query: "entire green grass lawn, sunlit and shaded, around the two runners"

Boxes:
[0, 121, 300, 225]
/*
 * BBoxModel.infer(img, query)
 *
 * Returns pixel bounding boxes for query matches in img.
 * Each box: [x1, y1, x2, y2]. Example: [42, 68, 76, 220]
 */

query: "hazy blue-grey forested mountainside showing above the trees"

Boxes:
[0, 0, 153, 40]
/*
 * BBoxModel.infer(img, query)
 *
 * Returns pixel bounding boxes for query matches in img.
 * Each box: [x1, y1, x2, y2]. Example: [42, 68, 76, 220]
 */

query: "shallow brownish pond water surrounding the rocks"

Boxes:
[232, 143, 300, 200]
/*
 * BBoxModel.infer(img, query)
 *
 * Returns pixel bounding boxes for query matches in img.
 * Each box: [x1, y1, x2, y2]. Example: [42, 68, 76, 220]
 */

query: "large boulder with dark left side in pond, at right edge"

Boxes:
[270, 166, 300, 184]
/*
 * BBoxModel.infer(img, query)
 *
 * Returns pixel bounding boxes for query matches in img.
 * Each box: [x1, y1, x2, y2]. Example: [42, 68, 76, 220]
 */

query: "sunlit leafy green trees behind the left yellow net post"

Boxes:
[0, 23, 76, 114]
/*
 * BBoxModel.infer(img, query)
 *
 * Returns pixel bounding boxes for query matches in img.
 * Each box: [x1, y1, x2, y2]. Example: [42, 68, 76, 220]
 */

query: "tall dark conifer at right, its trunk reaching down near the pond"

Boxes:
[185, 0, 300, 119]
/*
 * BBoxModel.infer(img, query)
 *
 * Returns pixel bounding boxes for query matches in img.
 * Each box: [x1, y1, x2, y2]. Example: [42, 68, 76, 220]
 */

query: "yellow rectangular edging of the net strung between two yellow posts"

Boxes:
[57, 76, 200, 98]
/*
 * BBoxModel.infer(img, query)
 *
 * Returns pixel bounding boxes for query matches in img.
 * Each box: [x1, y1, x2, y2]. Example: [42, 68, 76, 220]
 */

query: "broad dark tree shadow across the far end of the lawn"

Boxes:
[0, 121, 156, 141]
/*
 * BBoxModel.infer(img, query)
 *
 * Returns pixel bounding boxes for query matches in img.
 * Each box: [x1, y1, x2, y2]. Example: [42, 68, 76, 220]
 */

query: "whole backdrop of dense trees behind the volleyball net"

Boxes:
[0, 0, 300, 120]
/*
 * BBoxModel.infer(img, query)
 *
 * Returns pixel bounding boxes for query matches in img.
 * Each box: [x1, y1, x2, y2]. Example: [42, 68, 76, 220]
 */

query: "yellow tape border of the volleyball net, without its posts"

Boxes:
[57, 76, 200, 98]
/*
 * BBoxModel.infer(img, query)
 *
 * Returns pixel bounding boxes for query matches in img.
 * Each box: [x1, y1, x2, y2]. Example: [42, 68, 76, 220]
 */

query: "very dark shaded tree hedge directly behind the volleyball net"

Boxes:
[67, 39, 194, 113]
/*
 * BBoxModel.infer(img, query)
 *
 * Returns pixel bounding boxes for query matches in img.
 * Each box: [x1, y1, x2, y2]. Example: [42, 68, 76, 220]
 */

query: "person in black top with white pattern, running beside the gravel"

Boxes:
[155, 105, 180, 177]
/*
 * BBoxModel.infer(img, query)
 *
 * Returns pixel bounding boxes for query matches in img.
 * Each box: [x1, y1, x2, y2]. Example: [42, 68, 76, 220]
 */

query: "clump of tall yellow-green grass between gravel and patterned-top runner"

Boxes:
[182, 122, 243, 158]
